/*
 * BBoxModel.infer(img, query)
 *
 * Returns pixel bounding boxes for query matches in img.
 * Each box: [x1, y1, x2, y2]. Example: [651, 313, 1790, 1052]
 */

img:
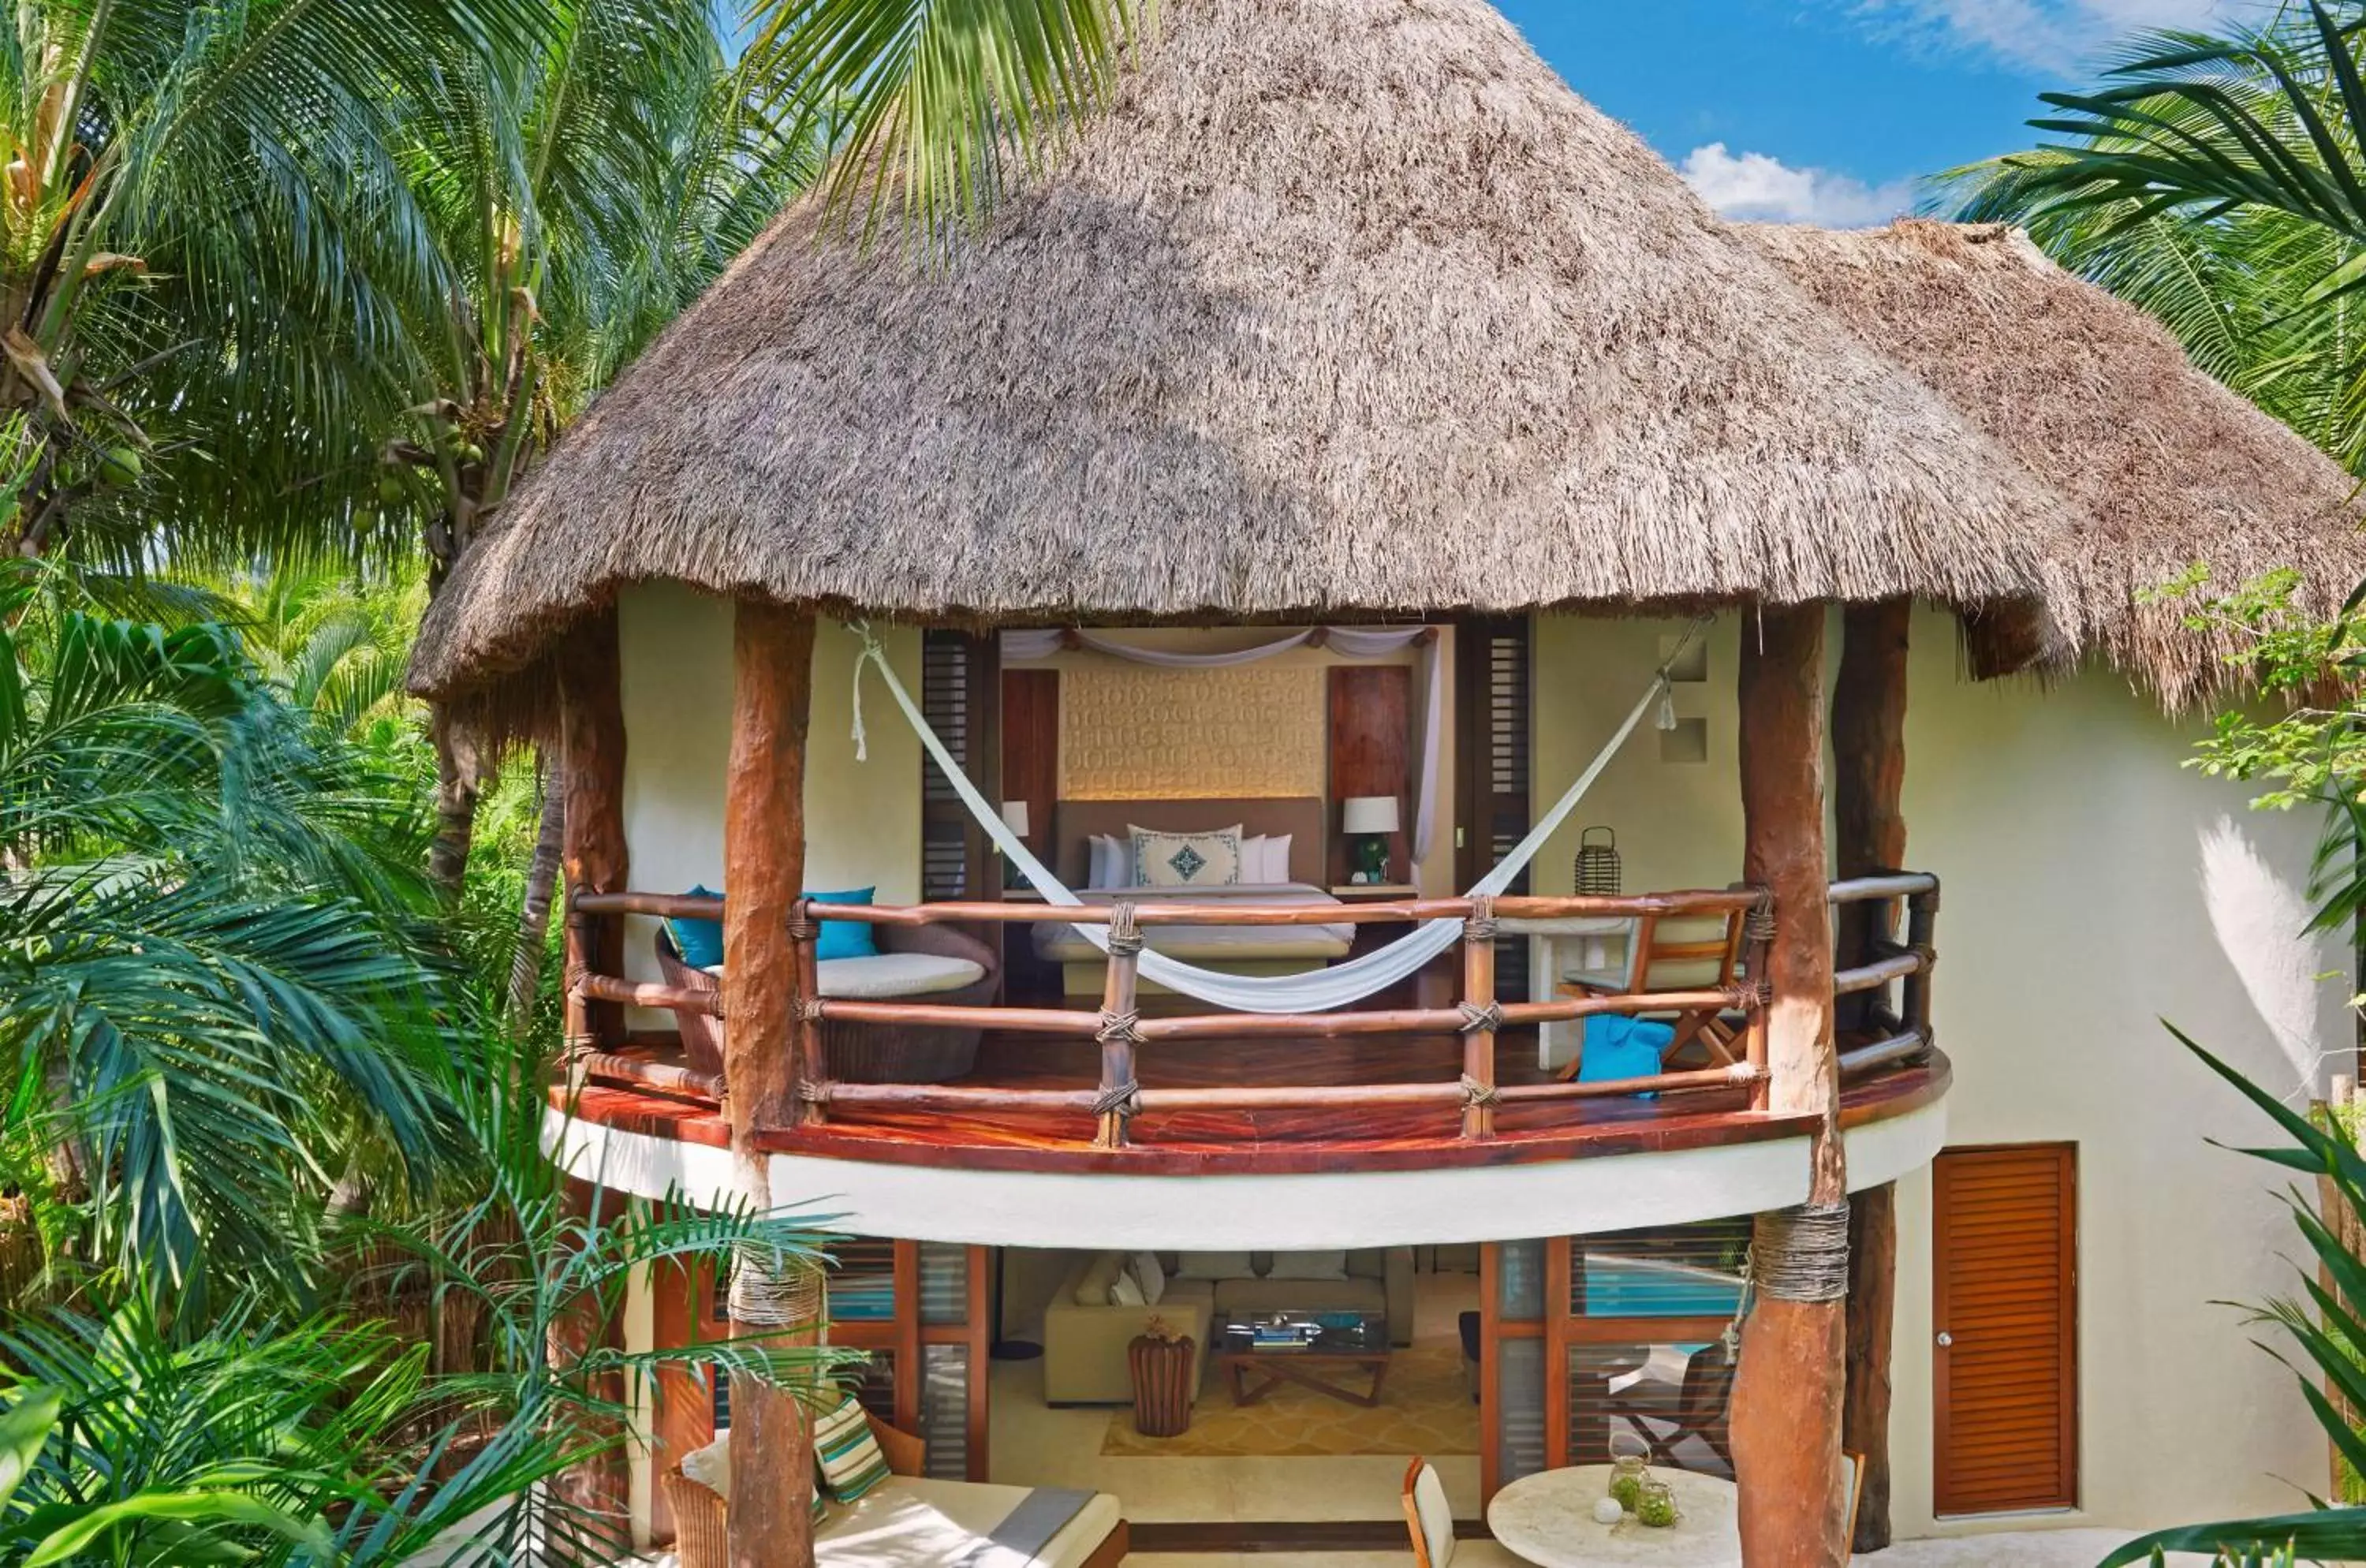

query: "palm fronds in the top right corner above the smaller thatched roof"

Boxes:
[1950, 0, 2366, 476]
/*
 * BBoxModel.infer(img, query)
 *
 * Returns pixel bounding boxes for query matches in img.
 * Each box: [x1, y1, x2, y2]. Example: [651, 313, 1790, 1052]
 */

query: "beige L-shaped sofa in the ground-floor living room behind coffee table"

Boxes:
[1043, 1246, 1413, 1405]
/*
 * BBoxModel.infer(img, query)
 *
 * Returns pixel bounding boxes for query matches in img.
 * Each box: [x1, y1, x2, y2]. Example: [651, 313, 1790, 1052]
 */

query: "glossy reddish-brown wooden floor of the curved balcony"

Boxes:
[563, 1031, 1950, 1173]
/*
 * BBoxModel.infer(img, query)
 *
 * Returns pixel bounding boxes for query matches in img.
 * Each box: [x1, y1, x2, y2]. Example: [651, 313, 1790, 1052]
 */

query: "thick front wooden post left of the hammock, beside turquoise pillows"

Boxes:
[724, 599, 814, 1568]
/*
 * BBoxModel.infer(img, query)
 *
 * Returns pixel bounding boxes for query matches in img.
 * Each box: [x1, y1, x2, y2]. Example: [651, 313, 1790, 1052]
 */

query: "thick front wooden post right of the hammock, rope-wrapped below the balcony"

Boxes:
[1732, 606, 1848, 1568]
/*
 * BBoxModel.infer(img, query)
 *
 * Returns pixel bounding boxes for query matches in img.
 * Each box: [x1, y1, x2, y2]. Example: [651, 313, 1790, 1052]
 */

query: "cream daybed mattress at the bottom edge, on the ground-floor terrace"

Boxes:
[814, 1478, 1119, 1568]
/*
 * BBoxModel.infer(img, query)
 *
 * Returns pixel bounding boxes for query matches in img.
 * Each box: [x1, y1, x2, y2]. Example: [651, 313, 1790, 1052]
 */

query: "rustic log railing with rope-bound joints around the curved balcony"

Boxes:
[568, 872, 1938, 1149]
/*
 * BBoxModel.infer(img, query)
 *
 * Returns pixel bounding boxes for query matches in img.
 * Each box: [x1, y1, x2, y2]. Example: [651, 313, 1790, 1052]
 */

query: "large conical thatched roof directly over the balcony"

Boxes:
[414, 0, 2099, 696]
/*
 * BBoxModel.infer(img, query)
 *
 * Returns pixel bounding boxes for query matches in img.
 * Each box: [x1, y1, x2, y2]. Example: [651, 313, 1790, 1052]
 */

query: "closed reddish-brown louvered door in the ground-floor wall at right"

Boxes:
[1931, 1144, 2077, 1514]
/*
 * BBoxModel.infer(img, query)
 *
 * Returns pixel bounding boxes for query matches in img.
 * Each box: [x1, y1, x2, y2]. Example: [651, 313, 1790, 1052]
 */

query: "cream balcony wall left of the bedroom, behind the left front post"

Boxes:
[618, 582, 920, 1026]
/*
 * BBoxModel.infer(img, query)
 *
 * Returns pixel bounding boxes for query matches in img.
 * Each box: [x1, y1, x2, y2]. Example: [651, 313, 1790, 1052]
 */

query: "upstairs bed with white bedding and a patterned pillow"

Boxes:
[1032, 797, 1356, 995]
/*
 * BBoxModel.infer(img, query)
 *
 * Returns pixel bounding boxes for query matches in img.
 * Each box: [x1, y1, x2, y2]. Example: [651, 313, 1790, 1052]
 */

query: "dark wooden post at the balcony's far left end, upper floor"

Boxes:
[554, 610, 632, 1052]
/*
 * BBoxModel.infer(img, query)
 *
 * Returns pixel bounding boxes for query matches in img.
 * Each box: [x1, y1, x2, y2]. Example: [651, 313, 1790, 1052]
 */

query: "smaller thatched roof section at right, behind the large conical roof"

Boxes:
[1744, 218, 2366, 707]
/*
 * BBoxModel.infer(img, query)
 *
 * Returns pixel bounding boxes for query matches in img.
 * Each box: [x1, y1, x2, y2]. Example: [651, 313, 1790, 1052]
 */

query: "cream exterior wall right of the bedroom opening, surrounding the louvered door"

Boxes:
[1536, 615, 2349, 1535]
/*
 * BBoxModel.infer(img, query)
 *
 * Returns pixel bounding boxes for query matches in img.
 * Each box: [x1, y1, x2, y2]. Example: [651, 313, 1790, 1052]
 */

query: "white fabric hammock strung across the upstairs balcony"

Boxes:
[849, 622, 1701, 1012]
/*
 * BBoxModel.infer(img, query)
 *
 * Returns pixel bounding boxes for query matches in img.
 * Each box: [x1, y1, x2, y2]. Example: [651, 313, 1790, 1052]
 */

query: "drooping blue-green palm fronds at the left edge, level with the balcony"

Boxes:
[0, 561, 452, 1296]
